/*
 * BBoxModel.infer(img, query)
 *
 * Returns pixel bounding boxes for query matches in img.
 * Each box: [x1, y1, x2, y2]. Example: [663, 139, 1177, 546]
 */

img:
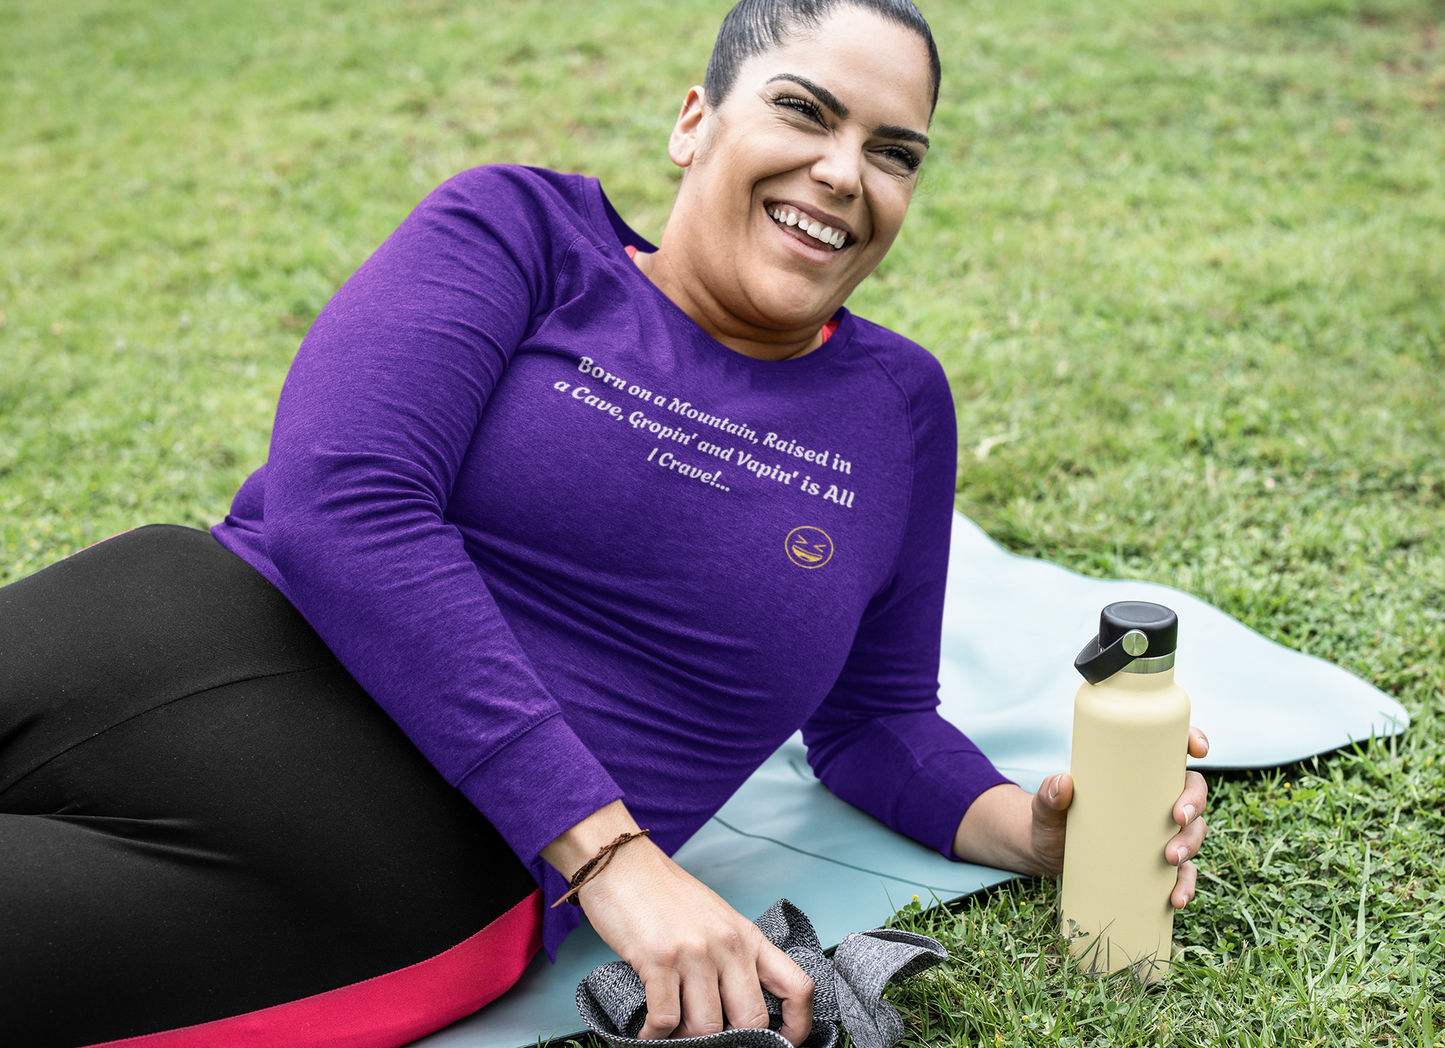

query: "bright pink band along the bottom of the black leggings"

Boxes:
[91, 889, 542, 1048]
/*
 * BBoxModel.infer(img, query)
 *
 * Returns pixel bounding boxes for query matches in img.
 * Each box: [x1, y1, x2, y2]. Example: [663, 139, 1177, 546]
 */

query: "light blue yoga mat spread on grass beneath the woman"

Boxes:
[416, 516, 1409, 1048]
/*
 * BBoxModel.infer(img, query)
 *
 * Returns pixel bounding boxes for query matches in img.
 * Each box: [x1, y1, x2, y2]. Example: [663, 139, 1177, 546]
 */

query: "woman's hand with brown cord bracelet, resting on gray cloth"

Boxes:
[542, 801, 814, 1045]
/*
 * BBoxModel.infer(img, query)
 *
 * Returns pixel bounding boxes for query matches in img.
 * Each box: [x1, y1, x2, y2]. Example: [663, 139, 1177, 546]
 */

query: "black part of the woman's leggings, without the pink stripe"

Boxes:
[0, 525, 536, 1048]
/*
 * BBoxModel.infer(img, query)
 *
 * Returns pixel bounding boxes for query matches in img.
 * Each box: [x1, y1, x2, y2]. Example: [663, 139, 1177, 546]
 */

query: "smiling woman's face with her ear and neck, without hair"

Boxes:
[663, 6, 932, 341]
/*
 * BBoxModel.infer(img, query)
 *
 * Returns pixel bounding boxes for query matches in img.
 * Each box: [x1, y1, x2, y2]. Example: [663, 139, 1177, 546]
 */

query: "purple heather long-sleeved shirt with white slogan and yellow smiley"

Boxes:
[214, 166, 1006, 953]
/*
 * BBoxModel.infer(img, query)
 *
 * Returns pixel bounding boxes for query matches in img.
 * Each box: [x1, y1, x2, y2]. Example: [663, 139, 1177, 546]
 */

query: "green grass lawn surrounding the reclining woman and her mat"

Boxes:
[0, 0, 1445, 1045]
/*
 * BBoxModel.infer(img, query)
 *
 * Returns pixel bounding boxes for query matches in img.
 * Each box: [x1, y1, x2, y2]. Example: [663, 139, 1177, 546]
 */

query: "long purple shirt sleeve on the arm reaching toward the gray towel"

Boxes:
[264, 168, 621, 863]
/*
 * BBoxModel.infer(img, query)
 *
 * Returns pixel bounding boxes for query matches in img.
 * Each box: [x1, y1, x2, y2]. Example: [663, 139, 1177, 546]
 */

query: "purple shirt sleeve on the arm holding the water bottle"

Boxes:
[803, 350, 1009, 859]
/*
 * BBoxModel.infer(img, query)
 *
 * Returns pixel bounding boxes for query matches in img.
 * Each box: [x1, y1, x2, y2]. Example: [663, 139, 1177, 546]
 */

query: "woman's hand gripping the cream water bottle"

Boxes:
[954, 727, 1209, 909]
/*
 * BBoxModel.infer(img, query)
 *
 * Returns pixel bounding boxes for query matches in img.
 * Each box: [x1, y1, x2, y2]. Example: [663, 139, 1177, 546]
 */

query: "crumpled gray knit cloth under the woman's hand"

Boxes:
[577, 899, 948, 1048]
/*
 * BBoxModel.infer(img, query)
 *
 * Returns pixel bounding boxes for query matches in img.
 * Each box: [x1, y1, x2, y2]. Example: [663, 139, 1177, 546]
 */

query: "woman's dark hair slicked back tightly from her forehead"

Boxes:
[702, 0, 944, 114]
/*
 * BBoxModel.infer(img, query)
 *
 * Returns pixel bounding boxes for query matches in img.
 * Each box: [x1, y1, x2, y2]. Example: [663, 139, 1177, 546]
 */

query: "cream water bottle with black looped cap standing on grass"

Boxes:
[1059, 601, 1189, 982]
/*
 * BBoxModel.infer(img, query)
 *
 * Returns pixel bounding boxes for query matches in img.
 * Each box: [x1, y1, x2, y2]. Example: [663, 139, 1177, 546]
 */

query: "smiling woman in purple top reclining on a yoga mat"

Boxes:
[0, 0, 1205, 1045]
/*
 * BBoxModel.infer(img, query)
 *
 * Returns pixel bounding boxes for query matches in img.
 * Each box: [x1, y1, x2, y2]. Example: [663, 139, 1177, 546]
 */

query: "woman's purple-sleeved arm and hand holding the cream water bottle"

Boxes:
[803, 345, 1208, 908]
